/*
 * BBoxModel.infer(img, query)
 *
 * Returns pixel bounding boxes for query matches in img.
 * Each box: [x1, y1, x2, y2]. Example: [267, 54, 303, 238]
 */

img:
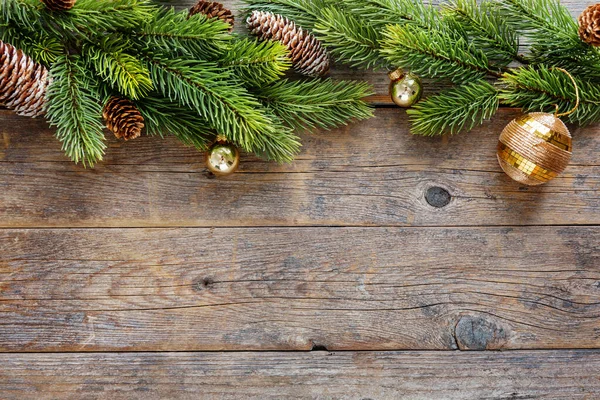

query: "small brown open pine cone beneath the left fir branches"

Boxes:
[102, 97, 144, 140]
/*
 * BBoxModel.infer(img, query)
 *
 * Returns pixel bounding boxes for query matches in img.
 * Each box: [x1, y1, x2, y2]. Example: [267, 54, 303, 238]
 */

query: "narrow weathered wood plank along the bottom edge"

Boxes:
[0, 351, 600, 400]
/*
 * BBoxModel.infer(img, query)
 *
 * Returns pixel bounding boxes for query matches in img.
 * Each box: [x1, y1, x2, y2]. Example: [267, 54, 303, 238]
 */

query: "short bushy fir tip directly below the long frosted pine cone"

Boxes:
[215, 39, 292, 87]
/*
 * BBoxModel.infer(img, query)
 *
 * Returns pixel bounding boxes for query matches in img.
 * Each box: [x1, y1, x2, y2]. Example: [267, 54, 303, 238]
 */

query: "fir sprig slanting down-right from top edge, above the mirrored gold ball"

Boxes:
[443, 0, 527, 65]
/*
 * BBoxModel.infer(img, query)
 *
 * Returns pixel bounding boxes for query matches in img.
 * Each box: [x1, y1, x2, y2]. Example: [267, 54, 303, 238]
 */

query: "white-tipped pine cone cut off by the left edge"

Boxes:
[0, 41, 49, 118]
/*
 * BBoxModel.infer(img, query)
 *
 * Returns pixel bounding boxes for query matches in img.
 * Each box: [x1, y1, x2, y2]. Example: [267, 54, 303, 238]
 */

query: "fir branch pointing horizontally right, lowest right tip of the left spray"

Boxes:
[257, 79, 373, 129]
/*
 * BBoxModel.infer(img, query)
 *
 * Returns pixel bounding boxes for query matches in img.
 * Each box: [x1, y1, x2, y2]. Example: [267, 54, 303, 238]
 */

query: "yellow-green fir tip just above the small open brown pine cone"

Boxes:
[83, 37, 153, 100]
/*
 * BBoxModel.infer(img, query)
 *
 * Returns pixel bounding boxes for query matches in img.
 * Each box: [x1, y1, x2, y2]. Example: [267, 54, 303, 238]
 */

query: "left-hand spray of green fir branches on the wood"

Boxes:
[0, 0, 372, 166]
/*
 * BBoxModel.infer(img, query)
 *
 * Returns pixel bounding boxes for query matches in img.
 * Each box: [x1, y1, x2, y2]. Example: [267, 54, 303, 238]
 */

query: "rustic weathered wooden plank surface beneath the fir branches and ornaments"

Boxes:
[0, 1, 600, 400]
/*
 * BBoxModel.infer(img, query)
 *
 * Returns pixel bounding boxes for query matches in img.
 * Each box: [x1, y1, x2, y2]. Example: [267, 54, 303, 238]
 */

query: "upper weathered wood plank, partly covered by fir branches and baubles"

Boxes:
[0, 109, 600, 227]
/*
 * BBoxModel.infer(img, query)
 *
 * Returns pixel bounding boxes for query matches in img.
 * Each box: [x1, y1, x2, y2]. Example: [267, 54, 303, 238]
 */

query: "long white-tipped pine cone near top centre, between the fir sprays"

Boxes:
[247, 11, 329, 76]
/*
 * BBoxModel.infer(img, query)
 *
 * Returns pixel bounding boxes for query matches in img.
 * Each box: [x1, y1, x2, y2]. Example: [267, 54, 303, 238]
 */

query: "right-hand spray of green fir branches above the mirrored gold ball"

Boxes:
[246, 0, 600, 136]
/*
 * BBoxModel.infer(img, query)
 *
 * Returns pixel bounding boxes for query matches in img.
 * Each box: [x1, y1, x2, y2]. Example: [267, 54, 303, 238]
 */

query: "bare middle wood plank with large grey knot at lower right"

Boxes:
[0, 227, 600, 352]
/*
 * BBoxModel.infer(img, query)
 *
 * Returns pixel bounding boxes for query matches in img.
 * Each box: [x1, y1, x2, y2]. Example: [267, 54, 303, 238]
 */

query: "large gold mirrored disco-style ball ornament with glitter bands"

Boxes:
[498, 113, 573, 186]
